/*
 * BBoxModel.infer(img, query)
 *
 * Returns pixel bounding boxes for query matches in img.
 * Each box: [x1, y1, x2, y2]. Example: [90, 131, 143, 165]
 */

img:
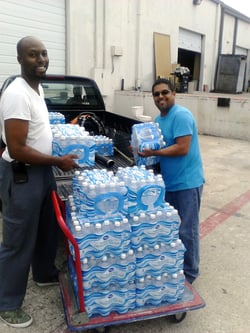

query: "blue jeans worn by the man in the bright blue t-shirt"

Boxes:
[165, 185, 203, 283]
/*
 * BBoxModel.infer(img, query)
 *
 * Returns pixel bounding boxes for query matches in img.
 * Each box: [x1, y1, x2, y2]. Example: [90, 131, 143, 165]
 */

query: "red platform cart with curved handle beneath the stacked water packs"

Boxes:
[52, 191, 205, 333]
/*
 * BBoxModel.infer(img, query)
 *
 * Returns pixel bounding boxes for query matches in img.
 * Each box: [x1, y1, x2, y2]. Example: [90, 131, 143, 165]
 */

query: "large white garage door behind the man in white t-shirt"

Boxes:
[0, 0, 65, 85]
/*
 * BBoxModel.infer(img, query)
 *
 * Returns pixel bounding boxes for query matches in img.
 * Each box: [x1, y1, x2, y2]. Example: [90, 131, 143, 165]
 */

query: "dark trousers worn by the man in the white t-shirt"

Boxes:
[0, 159, 58, 311]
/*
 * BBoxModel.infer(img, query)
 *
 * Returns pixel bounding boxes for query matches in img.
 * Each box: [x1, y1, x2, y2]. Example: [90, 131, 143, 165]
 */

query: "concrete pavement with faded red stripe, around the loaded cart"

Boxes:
[0, 135, 250, 333]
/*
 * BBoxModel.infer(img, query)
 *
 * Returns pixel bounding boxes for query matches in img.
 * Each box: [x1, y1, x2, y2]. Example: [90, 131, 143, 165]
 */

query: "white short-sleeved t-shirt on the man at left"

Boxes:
[0, 77, 52, 162]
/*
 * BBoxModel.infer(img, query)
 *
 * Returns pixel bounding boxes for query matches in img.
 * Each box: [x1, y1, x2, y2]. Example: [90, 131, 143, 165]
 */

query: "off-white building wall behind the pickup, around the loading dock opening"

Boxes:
[66, 0, 250, 111]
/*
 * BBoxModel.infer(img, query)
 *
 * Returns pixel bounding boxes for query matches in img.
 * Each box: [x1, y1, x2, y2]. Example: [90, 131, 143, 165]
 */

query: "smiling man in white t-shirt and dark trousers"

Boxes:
[0, 36, 78, 328]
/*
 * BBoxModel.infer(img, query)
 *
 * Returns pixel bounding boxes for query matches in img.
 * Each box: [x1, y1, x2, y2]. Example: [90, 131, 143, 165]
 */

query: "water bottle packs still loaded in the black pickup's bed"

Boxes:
[49, 112, 114, 167]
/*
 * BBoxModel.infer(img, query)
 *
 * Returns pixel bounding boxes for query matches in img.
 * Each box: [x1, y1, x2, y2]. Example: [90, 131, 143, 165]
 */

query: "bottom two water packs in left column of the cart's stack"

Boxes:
[82, 250, 135, 317]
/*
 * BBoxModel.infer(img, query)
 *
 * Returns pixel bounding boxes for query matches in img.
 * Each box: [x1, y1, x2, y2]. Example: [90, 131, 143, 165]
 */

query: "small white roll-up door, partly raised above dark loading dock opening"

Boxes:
[178, 29, 201, 53]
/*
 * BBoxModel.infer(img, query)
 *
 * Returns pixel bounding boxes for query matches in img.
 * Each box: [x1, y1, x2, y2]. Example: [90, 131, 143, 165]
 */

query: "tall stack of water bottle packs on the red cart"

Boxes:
[66, 166, 185, 317]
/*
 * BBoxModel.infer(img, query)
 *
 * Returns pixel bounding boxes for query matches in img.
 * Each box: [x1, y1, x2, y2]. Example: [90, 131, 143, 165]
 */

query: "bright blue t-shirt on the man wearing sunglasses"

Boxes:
[155, 104, 205, 192]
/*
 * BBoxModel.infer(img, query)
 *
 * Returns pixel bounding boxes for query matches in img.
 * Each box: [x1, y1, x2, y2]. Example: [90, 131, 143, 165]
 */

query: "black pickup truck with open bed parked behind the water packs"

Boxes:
[0, 75, 139, 198]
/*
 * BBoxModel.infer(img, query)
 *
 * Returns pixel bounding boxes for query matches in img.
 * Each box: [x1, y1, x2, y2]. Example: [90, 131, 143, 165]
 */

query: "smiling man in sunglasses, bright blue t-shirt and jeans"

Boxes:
[138, 79, 205, 283]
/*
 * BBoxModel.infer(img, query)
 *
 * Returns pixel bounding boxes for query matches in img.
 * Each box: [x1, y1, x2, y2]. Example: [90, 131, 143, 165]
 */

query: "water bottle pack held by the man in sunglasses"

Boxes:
[130, 122, 166, 166]
